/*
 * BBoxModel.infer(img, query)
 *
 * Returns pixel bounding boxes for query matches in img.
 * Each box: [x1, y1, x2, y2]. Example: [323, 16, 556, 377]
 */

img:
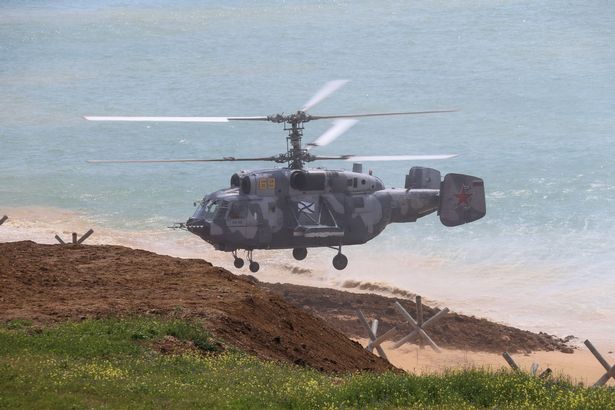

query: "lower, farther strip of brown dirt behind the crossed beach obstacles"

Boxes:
[261, 283, 572, 353]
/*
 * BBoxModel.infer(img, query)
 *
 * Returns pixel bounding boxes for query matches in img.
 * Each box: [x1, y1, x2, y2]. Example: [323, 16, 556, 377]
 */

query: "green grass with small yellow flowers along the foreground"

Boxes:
[0, 317, 615, 409]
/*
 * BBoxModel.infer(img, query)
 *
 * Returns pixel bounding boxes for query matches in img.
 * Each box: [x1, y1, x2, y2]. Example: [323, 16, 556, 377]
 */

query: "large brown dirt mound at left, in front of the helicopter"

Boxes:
[0, 242, 392, 372]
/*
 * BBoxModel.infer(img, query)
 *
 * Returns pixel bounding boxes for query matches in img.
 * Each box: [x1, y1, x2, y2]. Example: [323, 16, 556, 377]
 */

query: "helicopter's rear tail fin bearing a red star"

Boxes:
[438, 174, 486, 226]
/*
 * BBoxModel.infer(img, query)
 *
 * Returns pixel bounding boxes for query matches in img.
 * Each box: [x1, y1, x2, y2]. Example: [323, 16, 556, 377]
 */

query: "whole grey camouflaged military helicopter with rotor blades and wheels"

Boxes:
[84, 80, 486, 272]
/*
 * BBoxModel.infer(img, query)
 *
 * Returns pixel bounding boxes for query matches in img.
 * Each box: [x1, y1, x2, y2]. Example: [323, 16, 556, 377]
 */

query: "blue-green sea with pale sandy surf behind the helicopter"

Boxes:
[0, 0, 615, 345]
